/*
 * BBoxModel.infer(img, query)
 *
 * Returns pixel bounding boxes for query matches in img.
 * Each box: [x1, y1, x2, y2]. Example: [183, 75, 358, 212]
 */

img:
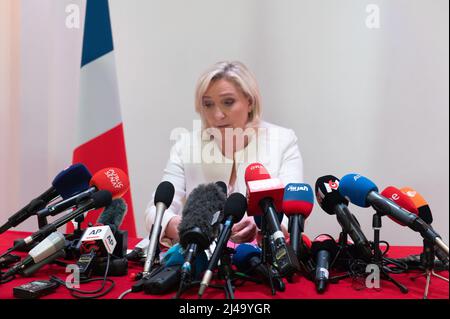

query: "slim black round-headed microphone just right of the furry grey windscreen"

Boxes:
[198, 193, 247, 298]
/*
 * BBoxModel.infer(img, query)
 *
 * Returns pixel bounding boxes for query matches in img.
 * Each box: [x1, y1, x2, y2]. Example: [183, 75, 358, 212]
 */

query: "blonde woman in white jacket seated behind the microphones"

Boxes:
[145, 61, 303, 247]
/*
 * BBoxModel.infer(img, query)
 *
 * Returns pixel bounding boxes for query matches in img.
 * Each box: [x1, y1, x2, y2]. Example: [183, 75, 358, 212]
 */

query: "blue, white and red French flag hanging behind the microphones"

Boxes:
[67, 0, 136, 237]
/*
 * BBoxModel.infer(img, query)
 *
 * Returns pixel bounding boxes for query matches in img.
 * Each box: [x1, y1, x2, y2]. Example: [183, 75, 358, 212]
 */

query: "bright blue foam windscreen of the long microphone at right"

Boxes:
[338, 174, 378, 207]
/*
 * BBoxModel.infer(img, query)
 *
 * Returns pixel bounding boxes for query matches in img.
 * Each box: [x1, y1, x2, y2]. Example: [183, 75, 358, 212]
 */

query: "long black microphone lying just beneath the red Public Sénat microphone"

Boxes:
[12, 190, 112, 255]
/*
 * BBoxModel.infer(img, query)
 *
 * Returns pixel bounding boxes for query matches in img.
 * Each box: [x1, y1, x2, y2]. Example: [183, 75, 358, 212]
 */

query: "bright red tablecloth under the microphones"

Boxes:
[0, 231, 449, 299]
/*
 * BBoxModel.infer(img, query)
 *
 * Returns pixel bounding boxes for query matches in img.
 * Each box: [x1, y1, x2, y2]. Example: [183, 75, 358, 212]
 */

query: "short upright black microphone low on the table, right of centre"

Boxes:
[311, 234, 338, 293]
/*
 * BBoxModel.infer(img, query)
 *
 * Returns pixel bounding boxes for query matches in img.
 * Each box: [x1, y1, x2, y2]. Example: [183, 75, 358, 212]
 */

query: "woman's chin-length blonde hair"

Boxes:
[195, 61, 261, 126]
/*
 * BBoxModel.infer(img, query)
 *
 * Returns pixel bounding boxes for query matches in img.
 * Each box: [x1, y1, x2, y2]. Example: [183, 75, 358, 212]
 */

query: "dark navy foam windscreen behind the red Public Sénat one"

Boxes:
[52, 164, 92, 199]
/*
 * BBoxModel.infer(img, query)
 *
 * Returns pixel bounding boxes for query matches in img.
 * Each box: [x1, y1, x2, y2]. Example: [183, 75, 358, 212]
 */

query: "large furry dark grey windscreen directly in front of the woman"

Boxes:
[178, 183, 226, 249]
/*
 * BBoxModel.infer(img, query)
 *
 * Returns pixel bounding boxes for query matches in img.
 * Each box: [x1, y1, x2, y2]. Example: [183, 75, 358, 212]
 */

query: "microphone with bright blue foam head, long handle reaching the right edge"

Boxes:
[339, 174, 449, 257]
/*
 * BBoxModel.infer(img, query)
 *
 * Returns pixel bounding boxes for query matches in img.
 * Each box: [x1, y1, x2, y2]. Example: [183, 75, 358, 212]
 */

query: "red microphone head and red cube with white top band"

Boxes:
[245, 163, 284, 216]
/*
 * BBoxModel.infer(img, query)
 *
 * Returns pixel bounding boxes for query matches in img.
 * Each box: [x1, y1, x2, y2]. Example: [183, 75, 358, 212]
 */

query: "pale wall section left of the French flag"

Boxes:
[0, 0, 84, 231]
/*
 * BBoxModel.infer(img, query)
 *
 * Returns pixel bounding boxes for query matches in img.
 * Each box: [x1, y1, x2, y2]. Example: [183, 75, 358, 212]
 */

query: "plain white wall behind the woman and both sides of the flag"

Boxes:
[0, 0, 449, 245]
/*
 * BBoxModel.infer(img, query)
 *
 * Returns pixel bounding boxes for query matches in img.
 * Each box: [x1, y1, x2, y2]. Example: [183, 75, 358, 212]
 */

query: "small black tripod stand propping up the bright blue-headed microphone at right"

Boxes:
[372, 211, 408, 294]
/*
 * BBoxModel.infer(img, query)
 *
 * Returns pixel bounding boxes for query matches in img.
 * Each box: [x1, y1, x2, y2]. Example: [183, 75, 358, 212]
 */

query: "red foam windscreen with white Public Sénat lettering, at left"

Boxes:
[90, 167, 130, 198]
